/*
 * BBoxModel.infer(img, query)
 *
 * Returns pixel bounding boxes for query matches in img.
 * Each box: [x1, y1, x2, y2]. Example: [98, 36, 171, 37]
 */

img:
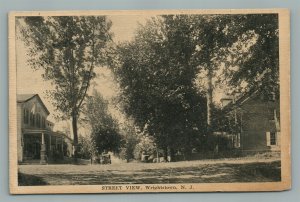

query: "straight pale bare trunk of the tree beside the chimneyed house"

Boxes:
[206, 67, 213, 135]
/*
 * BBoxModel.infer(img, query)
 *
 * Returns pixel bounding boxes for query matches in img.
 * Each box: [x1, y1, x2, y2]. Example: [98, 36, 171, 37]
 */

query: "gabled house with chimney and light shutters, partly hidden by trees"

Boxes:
[221, 90, 281, 152]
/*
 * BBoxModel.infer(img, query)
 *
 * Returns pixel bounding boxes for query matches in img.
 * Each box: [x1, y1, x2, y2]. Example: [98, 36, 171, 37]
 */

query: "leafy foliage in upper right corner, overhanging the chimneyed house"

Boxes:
[226, 14, 279, 97]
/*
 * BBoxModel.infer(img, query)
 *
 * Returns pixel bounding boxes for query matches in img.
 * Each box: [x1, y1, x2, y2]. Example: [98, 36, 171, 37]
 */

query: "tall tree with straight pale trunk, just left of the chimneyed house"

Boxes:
[190, 15, 243, 134]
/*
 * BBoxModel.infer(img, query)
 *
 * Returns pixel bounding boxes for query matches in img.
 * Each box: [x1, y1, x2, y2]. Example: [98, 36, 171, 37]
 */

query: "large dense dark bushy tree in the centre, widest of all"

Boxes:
[114, 16, 206, 158]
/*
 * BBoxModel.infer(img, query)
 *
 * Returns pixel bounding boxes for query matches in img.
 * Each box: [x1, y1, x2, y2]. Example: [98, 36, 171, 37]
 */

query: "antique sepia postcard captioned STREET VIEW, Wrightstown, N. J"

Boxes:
[9, 9, 291, 194]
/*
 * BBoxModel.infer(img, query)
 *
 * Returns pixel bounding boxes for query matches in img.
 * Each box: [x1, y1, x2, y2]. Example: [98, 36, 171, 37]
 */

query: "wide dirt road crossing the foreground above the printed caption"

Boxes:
[19, 159, 281, 185]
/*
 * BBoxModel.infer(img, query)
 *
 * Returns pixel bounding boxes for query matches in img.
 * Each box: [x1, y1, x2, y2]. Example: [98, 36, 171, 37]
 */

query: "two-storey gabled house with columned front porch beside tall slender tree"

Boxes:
[17, 94, 72, 164]
